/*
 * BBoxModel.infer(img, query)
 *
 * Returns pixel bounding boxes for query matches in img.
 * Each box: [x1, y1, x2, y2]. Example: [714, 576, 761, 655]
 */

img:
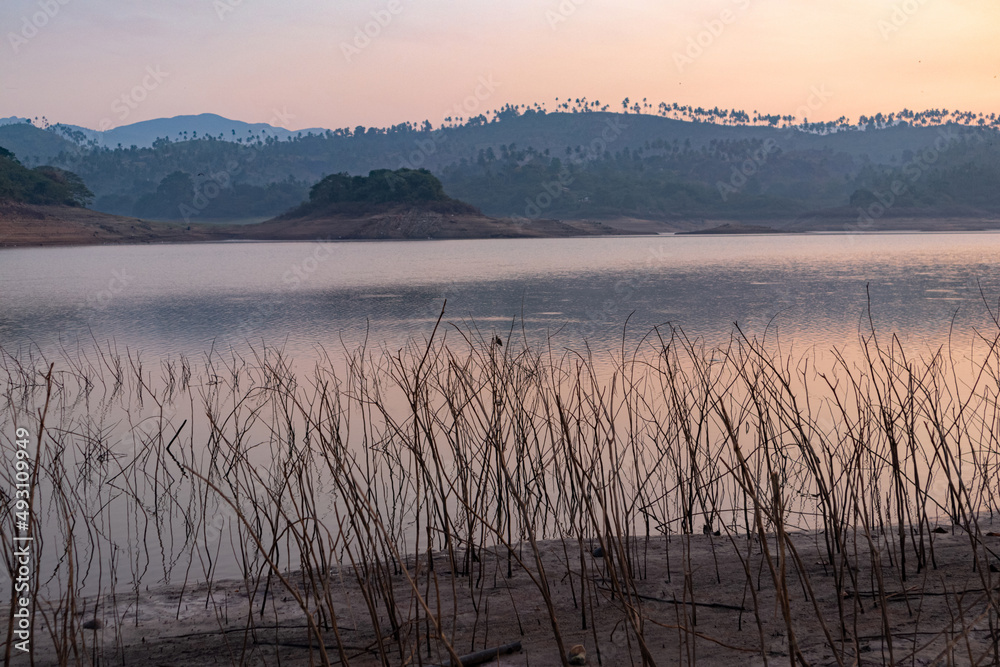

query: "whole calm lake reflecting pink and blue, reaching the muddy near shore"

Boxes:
[0, 233, 1000, 592]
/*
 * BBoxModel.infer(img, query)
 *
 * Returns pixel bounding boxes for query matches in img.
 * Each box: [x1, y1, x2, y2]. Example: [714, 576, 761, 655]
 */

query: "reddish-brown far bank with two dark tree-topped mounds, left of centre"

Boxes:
[0, 155, 630, 247]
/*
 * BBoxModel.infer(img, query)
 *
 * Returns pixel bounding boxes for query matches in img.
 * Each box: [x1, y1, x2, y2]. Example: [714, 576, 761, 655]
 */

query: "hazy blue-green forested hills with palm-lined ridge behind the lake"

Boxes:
[0, 98, 1000, 220]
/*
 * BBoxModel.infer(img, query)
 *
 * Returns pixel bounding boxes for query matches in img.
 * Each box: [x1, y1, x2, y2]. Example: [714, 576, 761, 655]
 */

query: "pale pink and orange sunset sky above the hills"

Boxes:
[0, 0, 1000, 129]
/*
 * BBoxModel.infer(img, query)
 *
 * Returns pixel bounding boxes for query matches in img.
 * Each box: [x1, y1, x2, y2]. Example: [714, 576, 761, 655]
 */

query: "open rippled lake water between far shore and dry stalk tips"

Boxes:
[0, 233, 1000, 360]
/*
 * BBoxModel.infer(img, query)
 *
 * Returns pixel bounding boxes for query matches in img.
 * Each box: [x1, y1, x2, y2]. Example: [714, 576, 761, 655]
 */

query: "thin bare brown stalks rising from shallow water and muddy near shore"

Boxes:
[0, 310, 1000, 665]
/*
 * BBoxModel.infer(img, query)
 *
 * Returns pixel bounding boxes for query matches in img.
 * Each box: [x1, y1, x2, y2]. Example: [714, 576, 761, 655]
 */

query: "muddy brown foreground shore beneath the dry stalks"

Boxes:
[15, 527, 1000, 666]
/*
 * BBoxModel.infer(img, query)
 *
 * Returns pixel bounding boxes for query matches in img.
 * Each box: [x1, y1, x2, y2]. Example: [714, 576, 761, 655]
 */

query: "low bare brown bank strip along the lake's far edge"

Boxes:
[0, 202, 1000, 249]
